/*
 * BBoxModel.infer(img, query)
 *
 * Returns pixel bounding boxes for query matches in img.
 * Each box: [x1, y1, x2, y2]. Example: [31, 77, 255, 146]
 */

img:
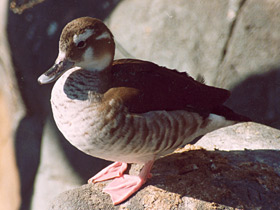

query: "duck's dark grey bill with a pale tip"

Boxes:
[38, 60, 74, 85]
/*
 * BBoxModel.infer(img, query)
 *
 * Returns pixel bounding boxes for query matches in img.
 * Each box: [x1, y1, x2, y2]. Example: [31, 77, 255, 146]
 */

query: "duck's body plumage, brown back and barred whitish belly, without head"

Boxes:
[51, 57, 232, 163]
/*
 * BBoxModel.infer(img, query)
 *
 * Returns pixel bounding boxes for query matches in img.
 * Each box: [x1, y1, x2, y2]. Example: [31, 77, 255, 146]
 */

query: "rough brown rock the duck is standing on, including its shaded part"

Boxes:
[49, 123, 280, 210]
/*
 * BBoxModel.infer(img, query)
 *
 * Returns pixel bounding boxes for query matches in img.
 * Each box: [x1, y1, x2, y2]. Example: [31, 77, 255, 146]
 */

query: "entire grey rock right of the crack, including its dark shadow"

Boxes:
[217, 0, 280, 129]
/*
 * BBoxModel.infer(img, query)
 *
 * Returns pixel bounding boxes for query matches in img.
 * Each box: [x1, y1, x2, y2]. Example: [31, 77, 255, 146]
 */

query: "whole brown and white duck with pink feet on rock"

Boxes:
[38, 17, 249, 205]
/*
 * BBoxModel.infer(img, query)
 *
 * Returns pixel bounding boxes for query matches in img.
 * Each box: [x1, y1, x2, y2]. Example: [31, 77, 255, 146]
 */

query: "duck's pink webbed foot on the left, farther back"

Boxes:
[88, 162, 127, 183]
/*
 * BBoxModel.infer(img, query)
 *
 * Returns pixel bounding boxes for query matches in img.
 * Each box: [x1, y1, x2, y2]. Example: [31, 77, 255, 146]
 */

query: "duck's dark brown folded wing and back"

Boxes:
[109, 59, 230, 113]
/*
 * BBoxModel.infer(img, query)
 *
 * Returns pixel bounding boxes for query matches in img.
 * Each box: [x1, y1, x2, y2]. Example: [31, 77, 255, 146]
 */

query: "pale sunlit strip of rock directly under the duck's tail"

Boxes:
[196, 123, 280, 151]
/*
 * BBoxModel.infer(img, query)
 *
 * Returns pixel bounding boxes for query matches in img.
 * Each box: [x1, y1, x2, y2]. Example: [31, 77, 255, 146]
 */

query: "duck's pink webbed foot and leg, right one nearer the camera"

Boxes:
[103, 160, 154, 205]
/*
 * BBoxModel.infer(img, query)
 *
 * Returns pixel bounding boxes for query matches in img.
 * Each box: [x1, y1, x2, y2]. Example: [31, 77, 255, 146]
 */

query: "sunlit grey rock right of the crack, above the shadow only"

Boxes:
[214, 0, 280, 89]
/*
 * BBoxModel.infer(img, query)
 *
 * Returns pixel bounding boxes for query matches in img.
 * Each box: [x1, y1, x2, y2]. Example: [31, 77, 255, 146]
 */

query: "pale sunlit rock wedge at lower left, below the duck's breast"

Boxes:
[31, 120, 83, 210]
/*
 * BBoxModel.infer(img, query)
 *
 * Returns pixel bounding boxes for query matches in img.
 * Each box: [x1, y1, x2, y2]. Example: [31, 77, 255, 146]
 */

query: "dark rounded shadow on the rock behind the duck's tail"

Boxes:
[226, 68, 280, 129]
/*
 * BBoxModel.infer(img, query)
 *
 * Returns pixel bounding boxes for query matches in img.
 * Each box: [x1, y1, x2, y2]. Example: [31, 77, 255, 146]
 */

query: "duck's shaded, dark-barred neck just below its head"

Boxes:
[63, 68, 111, 100]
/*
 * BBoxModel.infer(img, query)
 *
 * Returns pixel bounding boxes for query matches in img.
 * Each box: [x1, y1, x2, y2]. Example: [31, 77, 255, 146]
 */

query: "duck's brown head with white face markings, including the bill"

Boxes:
[38, 17, 115, 84]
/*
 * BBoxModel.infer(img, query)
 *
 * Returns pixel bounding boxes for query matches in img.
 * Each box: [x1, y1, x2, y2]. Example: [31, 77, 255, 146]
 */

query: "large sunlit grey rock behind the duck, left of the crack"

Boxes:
[108, 0, 246, 84]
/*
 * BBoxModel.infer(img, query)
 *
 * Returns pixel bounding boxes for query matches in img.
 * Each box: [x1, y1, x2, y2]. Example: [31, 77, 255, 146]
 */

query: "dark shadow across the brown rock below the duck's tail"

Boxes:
[147, 150, 280, 209]
